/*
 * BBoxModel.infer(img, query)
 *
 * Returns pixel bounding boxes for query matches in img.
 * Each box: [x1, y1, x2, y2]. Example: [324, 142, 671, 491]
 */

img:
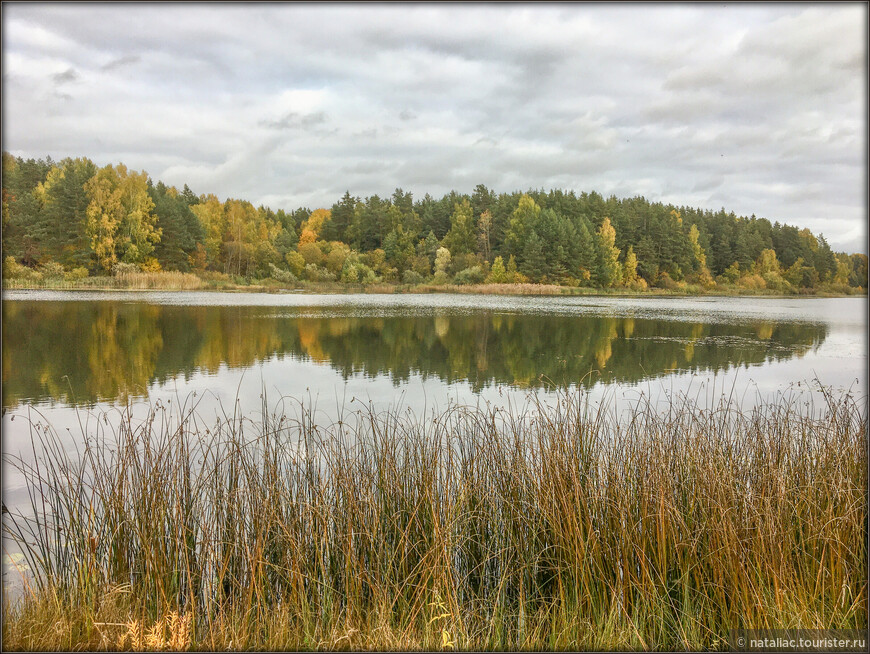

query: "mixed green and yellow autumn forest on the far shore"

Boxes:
[2, 152, 868, 293]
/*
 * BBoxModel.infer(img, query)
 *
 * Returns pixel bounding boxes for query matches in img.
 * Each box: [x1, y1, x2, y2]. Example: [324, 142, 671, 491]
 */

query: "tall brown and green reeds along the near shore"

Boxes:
[3, 393, 867, 650]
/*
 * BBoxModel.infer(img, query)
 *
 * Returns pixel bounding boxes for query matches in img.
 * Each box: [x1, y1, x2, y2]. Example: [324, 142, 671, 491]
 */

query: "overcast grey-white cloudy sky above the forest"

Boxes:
[2, 3, 867, 252]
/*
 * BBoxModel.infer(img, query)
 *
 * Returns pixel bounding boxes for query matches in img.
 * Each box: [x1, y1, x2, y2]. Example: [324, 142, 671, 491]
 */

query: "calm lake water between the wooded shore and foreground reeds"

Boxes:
[2, 291, 867, 588]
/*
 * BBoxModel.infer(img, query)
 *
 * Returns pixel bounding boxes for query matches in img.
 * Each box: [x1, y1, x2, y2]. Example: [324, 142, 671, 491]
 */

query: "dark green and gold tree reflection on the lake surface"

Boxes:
[2, 301, 828, 408]
